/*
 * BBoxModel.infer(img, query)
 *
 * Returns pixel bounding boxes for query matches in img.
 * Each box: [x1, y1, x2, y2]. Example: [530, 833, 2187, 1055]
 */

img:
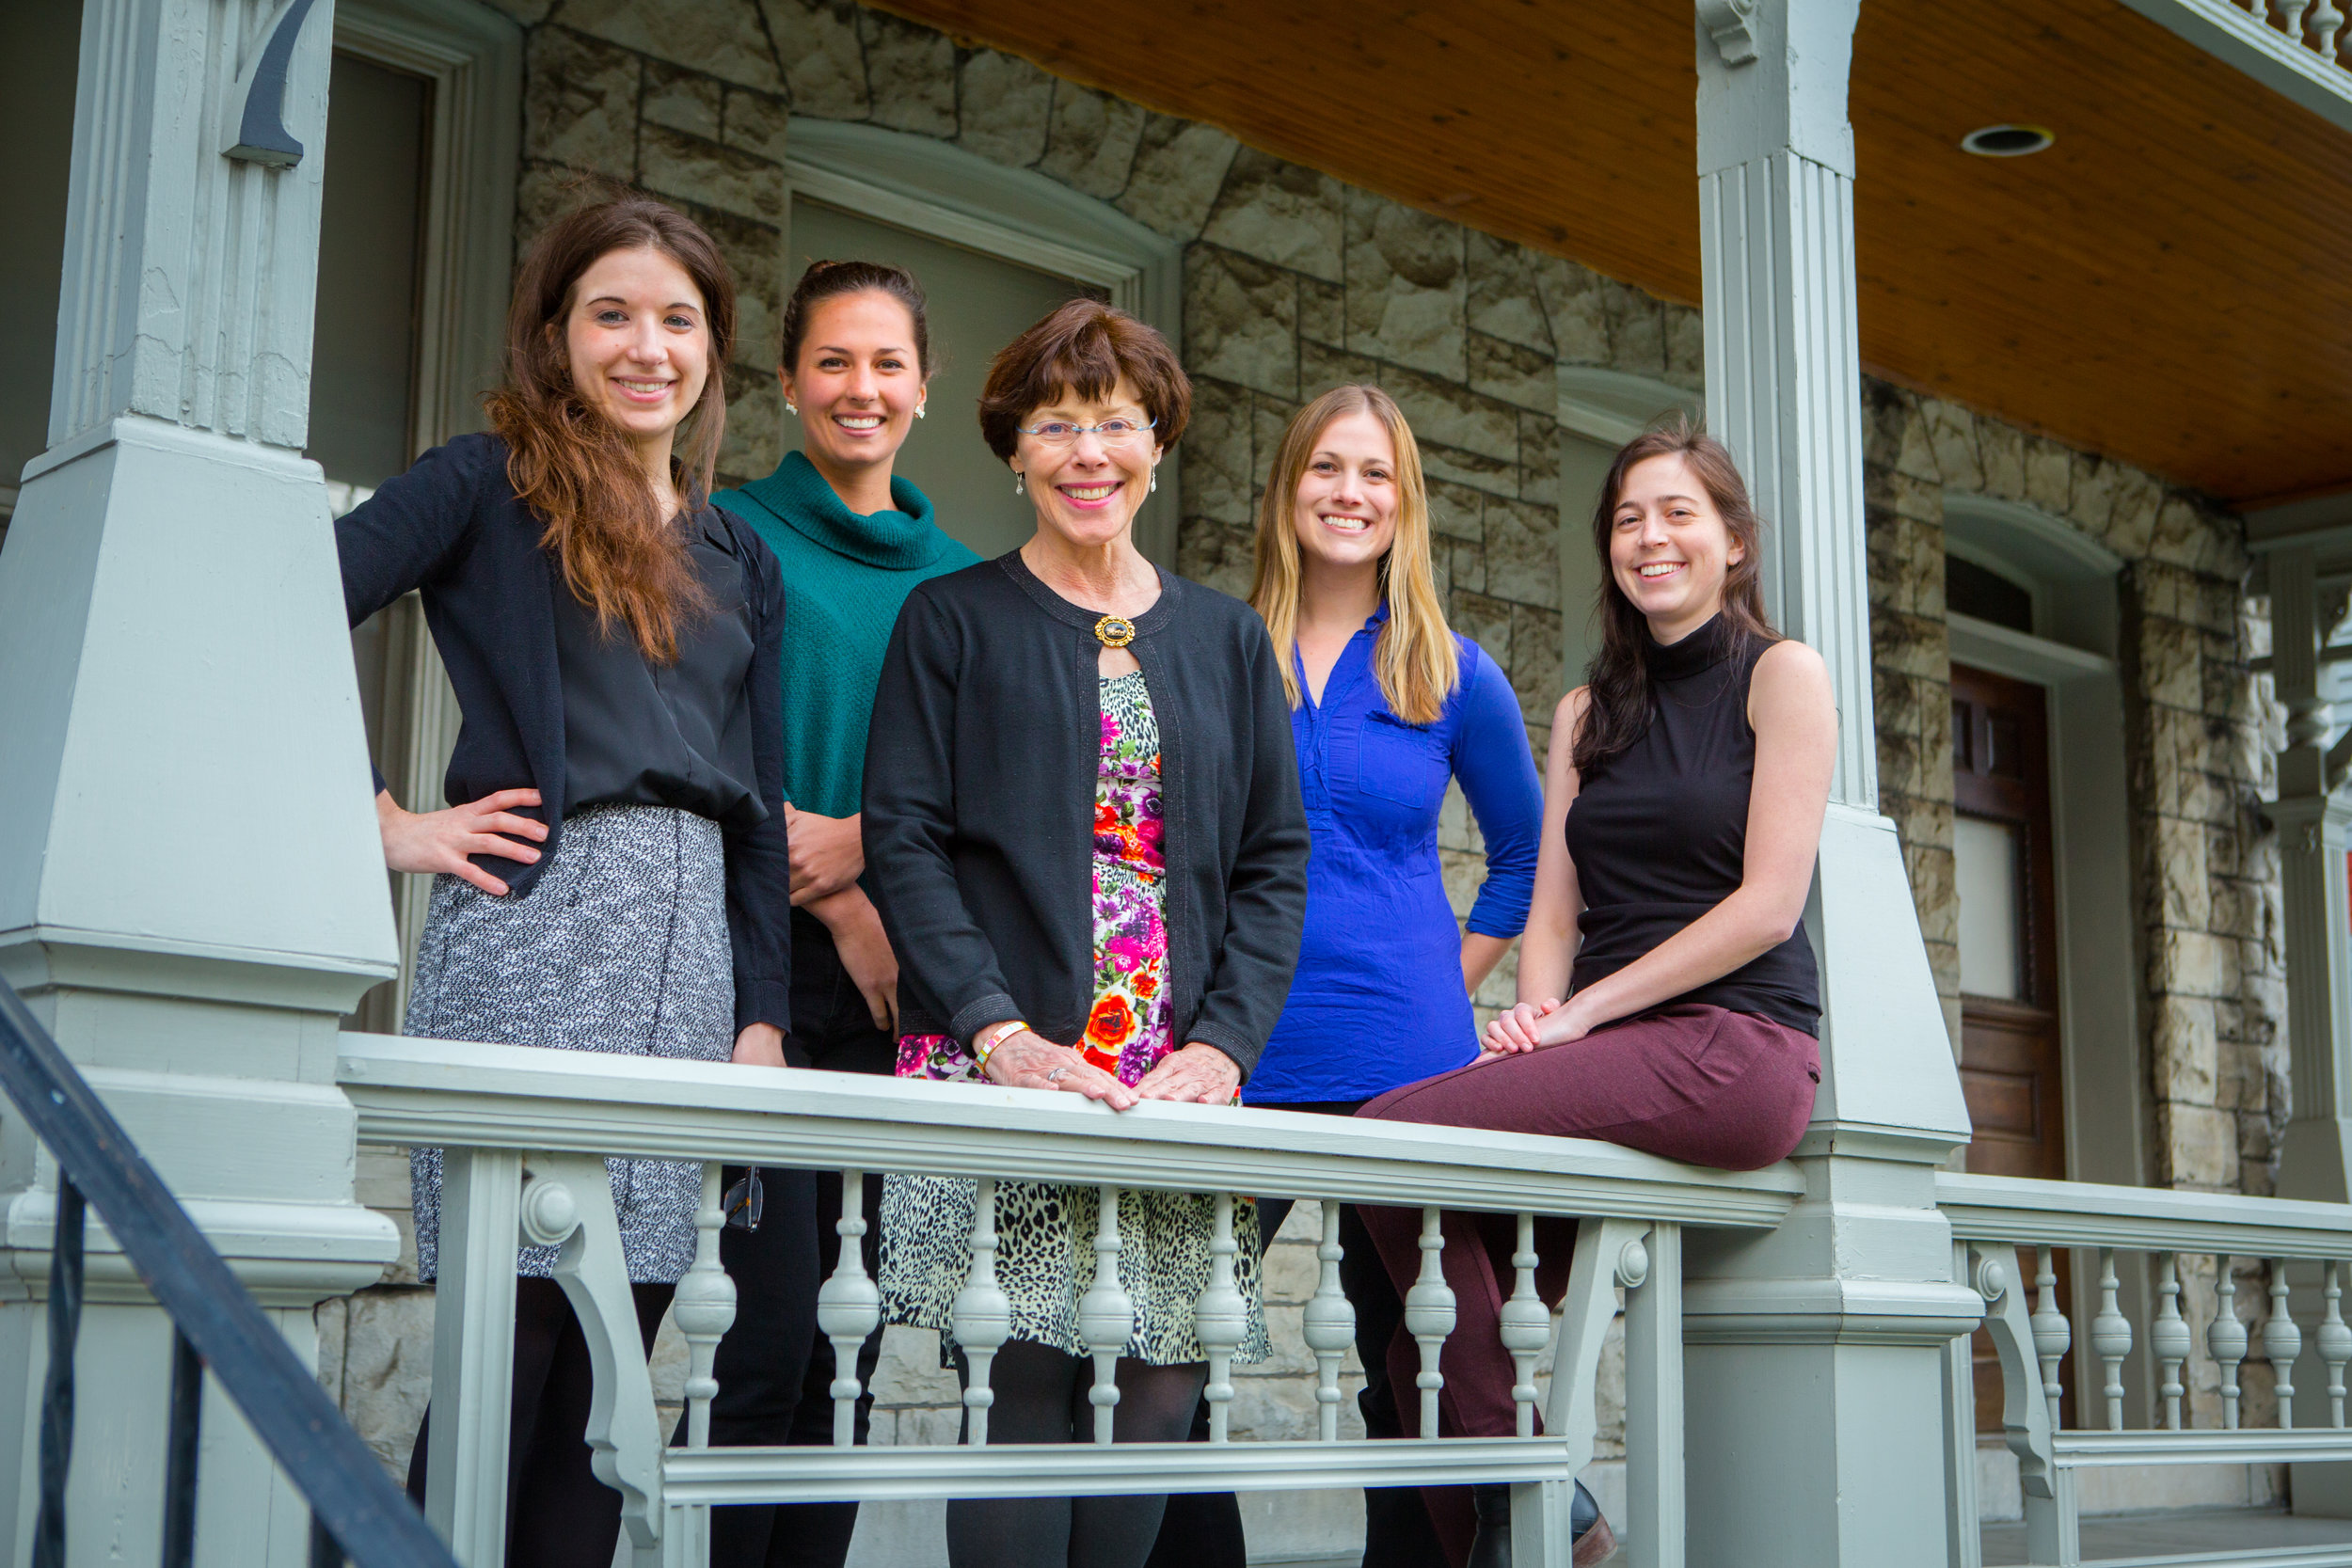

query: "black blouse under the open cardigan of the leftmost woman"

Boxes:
[555, 508, 767, 828]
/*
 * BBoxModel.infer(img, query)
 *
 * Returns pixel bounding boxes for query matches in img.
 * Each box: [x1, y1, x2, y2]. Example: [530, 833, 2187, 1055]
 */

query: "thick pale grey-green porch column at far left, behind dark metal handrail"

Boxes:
[0, 0, 398, 1568]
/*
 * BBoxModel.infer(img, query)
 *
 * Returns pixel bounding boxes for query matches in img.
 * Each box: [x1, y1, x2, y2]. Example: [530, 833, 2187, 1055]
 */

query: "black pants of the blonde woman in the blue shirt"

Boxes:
[1146, 1101, 1447, 1568]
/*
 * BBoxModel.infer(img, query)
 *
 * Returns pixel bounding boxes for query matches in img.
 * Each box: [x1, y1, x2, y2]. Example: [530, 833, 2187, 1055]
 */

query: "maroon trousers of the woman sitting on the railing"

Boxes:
[1358, 1006, 1820, 1561]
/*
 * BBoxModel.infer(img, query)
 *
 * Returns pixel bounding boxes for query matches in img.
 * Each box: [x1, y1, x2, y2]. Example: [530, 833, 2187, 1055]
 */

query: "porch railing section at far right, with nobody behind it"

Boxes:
[1936, 1173, 2352, 1568]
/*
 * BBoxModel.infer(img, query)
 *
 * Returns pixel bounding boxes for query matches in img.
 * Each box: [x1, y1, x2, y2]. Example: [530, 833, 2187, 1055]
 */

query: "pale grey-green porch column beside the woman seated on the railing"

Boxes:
[1684, 0, 1983, 1568]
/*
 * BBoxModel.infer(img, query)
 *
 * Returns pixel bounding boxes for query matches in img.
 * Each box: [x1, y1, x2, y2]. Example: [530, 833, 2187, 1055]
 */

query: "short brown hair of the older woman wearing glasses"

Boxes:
[981, 298, 1193, 461]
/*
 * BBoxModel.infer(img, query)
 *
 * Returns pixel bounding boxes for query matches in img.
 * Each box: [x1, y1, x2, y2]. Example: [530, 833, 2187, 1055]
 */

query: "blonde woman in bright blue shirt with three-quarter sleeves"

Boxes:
[1152, 386, 1543, 1568]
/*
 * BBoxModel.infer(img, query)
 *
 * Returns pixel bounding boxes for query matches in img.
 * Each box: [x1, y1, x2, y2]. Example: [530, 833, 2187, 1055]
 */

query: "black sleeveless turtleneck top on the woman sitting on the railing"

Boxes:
[1566, 616, 1820, 1035]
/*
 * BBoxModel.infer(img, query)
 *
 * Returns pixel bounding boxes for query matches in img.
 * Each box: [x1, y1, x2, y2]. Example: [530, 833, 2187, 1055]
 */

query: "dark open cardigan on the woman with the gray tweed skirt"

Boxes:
[334, 435, 793, 1030]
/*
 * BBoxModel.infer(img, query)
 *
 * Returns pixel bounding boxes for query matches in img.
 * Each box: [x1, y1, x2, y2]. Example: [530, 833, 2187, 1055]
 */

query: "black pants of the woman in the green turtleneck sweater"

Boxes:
[710, 910, 897, 1568]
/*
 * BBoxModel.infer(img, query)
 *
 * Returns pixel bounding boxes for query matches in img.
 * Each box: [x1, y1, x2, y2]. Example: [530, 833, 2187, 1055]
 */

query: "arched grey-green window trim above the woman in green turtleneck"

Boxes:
[784, 115, 1184, 569]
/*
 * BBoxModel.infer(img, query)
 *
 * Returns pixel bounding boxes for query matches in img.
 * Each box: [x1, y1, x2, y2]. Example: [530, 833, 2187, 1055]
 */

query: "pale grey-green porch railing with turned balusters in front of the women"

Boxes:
[339, 1035, 1802, 1568]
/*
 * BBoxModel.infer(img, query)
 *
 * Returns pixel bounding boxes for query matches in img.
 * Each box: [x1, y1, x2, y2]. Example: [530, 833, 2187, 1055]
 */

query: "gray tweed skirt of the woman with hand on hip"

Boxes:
[403, 806, 734, 1284]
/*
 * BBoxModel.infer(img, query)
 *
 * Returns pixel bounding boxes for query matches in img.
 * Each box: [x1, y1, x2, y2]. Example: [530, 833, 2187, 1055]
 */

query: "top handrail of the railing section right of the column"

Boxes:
[1936, 1171, 2352, 1258]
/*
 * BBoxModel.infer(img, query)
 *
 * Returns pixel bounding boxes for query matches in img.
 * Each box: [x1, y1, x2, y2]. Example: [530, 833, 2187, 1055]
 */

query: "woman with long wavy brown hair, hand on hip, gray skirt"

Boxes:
[337, 195, 814, 1568]
